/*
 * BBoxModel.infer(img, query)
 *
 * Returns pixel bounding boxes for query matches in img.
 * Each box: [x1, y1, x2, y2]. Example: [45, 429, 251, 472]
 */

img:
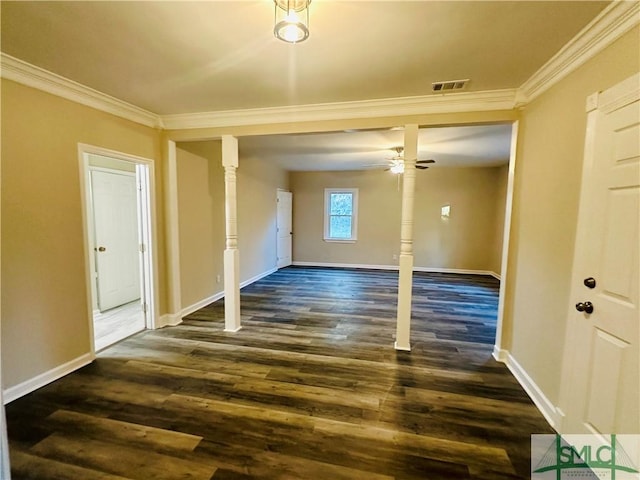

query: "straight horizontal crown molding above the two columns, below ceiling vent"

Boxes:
[161, 89, 516, 130]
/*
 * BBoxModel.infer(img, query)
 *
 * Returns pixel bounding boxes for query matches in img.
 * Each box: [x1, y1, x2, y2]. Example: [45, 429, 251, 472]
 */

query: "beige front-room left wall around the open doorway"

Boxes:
[1, 79, 164, 388]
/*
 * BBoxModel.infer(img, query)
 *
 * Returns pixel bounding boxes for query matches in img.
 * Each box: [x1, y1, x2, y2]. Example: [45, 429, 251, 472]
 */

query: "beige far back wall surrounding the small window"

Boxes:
[291, 167, 504, 270]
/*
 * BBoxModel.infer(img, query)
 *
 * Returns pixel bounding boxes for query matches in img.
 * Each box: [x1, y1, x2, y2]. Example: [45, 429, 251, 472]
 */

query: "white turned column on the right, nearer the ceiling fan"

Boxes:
[395, 125, 418, 351]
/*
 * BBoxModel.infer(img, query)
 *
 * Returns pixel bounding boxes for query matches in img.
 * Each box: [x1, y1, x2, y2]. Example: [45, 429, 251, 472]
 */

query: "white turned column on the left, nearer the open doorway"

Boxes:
[222, 135, 242, 332]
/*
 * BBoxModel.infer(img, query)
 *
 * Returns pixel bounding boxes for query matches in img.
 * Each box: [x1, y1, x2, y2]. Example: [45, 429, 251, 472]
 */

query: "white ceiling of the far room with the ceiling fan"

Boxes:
[239, 125, 511, 171]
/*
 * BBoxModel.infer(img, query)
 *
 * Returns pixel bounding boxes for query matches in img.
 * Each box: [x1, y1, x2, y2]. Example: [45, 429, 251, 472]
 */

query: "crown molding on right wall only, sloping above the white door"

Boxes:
[517, 0, 640, 106]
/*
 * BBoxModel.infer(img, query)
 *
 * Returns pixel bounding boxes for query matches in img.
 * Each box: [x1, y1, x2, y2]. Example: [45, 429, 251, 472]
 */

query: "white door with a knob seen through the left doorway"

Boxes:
[91, 170, 140, 311]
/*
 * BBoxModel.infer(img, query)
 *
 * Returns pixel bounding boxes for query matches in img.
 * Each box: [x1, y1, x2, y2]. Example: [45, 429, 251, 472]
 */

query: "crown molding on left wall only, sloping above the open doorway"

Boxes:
[0, 52, 162, 128]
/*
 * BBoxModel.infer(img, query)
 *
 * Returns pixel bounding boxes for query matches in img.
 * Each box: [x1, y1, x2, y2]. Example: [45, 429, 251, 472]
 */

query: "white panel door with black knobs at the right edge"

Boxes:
[561, 74, 640, 434]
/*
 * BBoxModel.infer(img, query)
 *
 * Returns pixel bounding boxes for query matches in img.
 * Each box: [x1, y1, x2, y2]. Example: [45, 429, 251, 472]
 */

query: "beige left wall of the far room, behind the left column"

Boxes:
[176, 140, 289, 309]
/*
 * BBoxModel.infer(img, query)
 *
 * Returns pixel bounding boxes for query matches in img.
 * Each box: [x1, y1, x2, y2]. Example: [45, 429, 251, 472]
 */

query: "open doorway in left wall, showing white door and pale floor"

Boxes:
[80, 146, 153, 351]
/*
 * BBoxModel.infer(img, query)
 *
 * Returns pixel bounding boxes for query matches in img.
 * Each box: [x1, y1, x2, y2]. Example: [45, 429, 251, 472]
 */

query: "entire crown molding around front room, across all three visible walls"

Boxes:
[0, 0, 640, 130]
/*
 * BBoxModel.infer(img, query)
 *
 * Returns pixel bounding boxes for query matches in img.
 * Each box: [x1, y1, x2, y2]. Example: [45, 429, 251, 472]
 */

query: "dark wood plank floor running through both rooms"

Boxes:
[7, 267, 553, 480]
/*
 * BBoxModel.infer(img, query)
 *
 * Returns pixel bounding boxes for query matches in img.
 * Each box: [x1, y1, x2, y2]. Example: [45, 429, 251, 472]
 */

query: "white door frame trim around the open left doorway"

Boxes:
[78, 143, 159, 358]
